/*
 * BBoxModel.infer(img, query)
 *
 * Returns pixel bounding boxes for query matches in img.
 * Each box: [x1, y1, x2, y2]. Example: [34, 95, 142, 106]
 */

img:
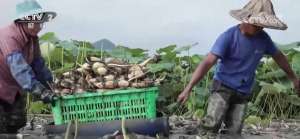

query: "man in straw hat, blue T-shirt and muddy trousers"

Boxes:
[178, 0, 299, 135]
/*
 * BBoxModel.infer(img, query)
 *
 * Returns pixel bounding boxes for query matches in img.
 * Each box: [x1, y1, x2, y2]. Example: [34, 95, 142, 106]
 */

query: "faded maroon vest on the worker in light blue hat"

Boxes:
[0, 23, 40, 104]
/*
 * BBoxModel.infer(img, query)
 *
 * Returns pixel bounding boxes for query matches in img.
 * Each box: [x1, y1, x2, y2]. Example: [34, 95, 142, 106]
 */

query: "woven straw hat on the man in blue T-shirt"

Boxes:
[230, 0, 288, 30]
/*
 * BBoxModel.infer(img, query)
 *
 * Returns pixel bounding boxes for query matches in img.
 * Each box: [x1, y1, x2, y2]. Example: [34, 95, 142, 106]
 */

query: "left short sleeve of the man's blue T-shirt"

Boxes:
[210, 32, 231, 59]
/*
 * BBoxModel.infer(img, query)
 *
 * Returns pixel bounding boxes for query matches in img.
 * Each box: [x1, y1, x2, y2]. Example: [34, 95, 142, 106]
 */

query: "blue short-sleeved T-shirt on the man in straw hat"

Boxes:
[211, 25, 278, 95]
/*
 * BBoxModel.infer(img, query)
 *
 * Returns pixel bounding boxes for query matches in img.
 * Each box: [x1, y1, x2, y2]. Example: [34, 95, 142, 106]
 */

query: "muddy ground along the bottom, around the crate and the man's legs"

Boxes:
[14, 116, 300, 139]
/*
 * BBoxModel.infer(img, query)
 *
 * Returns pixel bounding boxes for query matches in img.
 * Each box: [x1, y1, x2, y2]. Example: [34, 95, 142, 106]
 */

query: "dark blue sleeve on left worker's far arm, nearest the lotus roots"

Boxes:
[31, 57, 53, 86]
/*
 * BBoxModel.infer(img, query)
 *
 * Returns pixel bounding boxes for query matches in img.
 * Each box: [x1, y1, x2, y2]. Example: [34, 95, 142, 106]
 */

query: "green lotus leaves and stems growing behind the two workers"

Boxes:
[29, 32, 300, 119]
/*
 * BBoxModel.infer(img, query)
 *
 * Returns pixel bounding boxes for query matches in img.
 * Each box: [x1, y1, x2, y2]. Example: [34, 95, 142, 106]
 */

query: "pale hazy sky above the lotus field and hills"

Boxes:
[0, 0, 300, 54]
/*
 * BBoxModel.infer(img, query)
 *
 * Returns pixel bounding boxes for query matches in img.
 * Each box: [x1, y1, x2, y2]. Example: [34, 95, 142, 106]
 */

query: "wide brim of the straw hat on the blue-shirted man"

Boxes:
[229, 9, 288, 30]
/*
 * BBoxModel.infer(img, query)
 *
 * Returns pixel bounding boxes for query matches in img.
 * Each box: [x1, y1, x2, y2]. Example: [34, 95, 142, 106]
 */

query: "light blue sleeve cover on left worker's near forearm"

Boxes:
[6, 52, 39, 92]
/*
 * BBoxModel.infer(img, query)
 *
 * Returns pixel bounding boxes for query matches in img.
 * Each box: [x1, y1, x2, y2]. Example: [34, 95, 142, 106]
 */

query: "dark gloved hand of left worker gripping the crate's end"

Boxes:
[32, 83, 55, 103]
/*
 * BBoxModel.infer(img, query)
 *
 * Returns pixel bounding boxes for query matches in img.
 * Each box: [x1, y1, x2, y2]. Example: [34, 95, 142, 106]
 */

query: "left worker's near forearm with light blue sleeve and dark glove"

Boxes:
[6, 52, 54, 103]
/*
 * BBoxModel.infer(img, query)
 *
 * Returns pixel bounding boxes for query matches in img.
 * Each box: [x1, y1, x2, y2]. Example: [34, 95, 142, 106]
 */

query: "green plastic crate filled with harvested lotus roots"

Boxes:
[52, 87, 158, 125]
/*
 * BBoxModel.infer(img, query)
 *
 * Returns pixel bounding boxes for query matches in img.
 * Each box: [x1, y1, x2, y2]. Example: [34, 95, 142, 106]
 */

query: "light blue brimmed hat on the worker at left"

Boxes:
[14, 0, 56, 22]
